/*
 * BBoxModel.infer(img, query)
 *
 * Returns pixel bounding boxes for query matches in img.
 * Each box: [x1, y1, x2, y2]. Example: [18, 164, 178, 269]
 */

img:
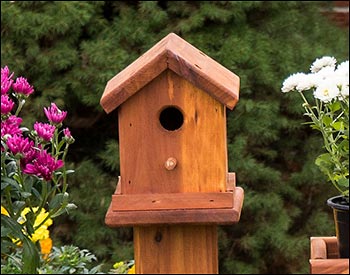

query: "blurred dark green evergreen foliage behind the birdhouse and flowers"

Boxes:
[1, 1, 349, 274]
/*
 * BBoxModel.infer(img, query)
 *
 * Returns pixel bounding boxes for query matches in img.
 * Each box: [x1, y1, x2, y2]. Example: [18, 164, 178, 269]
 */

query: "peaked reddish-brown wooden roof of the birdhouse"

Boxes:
[100, 33, 239, 113]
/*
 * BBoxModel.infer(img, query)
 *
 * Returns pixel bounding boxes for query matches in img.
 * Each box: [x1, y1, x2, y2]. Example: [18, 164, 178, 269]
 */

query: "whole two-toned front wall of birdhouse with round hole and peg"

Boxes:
[118, 69, 227, 194]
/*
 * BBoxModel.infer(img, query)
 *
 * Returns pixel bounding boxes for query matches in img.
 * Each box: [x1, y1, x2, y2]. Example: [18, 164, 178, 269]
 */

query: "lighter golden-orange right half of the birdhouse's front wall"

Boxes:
[175, 75, 227, 192]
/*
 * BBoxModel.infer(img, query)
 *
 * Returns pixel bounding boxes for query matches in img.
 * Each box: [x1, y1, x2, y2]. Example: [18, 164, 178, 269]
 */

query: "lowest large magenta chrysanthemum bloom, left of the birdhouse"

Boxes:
[23, 150, 64, 181]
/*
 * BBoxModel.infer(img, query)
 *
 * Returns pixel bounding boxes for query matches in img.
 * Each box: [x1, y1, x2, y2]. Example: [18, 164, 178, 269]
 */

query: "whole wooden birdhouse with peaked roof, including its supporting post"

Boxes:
[101, 33, 243, 273]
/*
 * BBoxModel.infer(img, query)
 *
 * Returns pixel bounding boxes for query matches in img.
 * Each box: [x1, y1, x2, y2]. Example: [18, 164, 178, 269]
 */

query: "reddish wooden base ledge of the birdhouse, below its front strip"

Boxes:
[105, 187, 244, 227]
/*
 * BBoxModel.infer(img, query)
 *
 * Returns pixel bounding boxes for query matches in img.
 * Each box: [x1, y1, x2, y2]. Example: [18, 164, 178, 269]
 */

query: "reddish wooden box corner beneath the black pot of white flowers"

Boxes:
[309, 237, 349, 274]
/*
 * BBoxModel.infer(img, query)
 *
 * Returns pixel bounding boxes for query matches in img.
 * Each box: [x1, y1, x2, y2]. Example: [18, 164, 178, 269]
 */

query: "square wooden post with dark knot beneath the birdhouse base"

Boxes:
[134, 225, 218, 274]
